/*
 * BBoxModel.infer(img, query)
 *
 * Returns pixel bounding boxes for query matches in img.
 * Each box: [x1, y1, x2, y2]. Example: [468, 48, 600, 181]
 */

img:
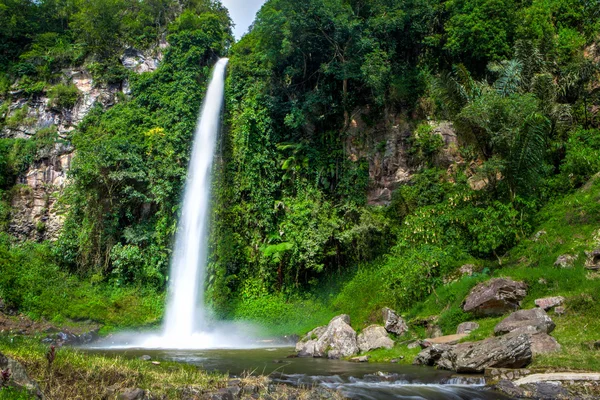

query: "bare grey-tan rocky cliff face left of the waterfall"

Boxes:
[0, 47, 167, 241]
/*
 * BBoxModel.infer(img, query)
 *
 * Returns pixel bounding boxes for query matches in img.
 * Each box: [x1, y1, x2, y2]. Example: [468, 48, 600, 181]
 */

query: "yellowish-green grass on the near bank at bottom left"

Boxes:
[0, 336, 227, 399]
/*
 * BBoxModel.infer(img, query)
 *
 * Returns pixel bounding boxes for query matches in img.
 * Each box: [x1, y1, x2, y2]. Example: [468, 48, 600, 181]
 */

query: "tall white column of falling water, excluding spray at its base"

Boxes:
[164, 58, 229, 341]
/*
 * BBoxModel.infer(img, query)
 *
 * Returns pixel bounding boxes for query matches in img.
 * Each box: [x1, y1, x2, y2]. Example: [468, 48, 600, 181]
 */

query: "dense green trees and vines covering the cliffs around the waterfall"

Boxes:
[0, 0, 600, 329]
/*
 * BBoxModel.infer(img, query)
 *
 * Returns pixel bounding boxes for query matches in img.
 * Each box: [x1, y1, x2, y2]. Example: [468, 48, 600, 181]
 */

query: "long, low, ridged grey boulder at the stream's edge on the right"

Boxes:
[437, 334, 532, 373]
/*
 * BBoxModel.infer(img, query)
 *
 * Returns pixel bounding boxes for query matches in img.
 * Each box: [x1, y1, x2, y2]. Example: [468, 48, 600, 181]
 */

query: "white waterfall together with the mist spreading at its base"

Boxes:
[93, 58, 273, 350]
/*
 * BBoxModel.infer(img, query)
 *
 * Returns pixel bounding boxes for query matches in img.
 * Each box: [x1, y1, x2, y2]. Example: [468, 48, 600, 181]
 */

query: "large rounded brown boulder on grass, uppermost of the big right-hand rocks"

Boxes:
[463, 278, 527, 316]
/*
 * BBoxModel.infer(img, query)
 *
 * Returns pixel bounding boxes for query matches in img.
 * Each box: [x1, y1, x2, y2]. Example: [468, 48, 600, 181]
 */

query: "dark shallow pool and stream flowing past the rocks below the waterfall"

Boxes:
[89, 348, 508, 400]
